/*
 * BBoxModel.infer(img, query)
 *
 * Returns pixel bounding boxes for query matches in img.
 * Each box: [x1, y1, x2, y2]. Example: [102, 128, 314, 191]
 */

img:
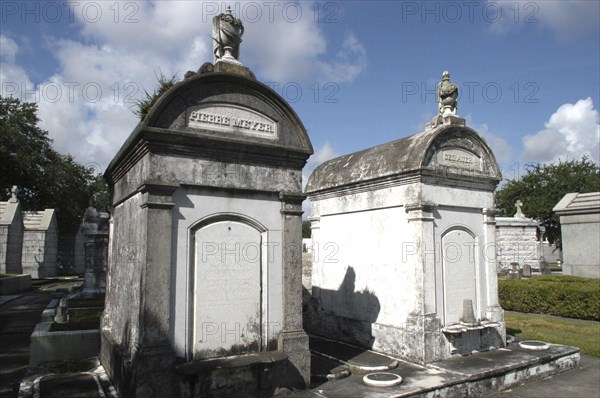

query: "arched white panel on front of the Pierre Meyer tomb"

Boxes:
[193, 217, 263, 358]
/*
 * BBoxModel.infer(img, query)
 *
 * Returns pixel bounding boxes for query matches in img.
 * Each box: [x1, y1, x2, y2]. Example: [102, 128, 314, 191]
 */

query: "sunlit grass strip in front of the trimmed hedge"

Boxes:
[504, 311, 600, 357]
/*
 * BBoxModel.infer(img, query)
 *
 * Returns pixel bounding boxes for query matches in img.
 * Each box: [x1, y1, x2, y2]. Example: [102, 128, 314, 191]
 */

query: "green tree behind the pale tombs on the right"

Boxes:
[496, 156, 600, 247]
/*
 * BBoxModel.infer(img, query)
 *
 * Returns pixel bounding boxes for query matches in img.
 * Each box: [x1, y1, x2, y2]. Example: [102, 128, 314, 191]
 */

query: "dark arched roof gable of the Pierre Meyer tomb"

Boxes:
[107, 72, 313, 180]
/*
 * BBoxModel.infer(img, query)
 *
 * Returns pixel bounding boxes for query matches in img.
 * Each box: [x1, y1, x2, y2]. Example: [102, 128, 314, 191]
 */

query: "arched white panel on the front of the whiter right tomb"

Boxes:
[441, 228, 479, 324]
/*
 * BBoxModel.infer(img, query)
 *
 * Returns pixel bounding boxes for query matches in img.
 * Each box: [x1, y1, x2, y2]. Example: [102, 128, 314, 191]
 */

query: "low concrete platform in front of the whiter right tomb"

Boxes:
[298, 337, 579, 398]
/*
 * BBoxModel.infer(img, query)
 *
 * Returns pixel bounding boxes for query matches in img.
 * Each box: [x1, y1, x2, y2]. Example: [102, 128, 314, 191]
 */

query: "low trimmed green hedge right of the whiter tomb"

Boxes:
[498, 275, 600, 321]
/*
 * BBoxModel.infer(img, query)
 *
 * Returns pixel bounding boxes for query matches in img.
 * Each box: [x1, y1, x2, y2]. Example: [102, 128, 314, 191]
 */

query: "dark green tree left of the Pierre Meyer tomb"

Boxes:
[0, 96, 102, 231]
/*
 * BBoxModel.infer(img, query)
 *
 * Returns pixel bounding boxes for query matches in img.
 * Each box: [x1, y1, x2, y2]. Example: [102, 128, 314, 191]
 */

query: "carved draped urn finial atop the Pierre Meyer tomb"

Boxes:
[213, 6, 244, 65]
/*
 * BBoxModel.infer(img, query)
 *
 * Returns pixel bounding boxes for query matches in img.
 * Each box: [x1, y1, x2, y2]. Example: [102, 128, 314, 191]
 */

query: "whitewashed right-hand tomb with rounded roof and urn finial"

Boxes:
[306, 73, 505, 363]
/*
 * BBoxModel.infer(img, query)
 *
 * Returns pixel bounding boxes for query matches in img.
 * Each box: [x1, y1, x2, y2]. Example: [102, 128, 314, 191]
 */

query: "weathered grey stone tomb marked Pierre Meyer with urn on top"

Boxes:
[101, 7, 313, 398]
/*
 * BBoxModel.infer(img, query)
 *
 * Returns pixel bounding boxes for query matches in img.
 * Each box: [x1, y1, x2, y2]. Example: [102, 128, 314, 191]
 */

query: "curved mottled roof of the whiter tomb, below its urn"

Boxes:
[306, 124, 502, 195]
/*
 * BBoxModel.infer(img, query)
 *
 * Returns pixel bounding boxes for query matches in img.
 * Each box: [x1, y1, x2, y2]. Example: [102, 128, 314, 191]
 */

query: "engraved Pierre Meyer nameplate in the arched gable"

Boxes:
[188, 105, 278, 139]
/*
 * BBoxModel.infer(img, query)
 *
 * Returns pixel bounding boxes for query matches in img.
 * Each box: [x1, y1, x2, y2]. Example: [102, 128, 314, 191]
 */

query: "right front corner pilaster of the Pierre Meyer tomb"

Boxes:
[278, 192, 310, 387]
